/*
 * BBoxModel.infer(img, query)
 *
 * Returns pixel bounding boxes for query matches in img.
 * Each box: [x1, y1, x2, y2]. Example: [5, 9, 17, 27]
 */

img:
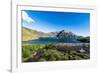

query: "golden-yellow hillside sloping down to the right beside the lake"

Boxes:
[22, 27, 55, 41]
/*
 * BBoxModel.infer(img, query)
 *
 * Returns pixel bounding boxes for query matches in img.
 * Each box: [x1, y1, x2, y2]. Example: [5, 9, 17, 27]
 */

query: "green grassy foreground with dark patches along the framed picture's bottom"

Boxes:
[22, 44, 90, 62]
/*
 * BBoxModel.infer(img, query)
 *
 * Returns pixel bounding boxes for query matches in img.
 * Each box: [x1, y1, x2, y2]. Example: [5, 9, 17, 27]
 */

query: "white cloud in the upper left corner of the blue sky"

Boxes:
[22, 11, 35, 24]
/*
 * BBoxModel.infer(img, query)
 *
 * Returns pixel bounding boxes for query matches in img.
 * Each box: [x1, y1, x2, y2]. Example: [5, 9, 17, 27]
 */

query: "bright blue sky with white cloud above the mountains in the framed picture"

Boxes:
[22, 10, 90, 36]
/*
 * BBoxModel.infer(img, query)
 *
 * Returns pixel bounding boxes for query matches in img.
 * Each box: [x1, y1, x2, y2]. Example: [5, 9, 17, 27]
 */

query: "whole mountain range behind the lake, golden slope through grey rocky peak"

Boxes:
[22, 27, 78, 41]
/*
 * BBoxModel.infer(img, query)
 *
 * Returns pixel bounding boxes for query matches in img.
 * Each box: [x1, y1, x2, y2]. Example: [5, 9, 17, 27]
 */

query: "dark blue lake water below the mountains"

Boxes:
[23, 37, 80, 44]
